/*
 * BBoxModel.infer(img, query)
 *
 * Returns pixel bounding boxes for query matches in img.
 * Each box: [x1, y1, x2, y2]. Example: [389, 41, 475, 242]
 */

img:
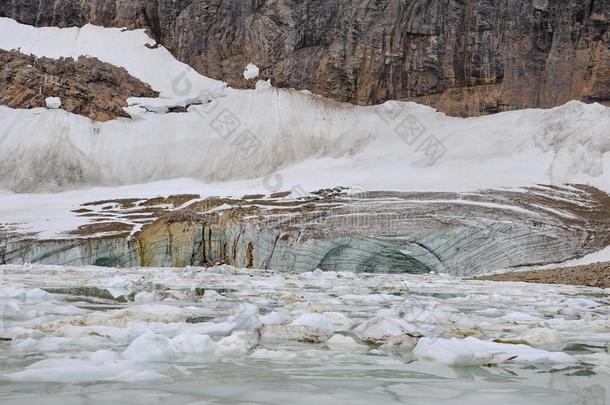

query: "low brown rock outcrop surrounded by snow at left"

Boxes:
[0, 50, 159, 121]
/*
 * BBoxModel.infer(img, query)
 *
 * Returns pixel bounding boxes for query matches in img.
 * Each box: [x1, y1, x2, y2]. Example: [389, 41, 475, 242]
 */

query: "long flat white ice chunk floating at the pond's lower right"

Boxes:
[413, 337, 575, 366]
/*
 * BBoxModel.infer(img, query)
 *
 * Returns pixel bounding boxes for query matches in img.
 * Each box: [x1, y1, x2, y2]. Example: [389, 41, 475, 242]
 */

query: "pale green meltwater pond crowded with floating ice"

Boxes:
[0, 266, 610, 405]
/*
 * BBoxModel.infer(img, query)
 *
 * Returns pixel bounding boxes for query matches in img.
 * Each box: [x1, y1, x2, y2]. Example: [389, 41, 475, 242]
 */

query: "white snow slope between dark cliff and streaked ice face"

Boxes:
[0, 18, 610, 196]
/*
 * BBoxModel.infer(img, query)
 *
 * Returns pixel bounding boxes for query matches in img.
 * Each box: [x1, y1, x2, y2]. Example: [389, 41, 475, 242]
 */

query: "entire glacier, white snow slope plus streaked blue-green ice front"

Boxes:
[0, 18, 610, 275]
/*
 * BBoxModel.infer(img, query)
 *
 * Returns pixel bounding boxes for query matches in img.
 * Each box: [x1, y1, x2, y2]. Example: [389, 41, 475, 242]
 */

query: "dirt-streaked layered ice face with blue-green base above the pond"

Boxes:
[0, 186, 610, 275]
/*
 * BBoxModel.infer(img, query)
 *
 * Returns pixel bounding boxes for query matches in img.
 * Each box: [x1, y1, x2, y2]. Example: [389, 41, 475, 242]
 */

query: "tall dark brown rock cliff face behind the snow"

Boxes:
[0, 0, 610, 116]
